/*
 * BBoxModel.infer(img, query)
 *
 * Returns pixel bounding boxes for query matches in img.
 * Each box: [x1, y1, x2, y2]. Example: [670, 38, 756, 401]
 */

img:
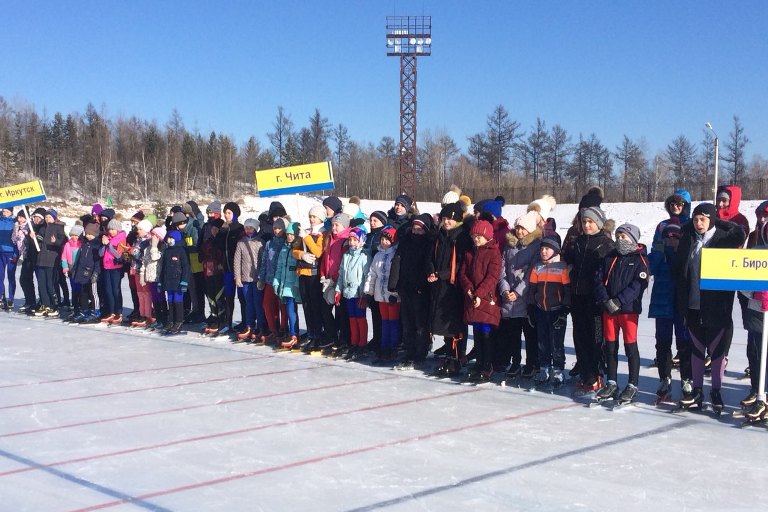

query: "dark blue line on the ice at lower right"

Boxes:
[347, 420, 694, 512]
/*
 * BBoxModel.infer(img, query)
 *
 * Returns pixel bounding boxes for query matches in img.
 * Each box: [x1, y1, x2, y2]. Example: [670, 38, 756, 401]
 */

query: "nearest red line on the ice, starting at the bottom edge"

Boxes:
[70, 403, 583, 512]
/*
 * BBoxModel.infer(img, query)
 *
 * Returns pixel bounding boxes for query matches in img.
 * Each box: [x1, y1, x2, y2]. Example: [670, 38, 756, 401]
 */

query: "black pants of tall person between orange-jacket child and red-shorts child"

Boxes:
[571, 295, 603, 384]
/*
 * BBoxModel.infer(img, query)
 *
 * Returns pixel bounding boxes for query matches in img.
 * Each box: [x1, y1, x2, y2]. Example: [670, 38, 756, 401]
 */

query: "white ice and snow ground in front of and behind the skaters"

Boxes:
[0, 194, 768, 512]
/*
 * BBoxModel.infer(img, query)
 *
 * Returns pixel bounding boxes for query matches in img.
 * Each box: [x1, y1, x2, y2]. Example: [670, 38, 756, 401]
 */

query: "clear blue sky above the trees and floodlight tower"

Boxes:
[0, 0, 768, 160]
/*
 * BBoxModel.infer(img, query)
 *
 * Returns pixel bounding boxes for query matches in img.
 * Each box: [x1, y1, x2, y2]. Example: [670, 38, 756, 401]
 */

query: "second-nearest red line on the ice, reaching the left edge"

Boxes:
[0, 386, 480, 477]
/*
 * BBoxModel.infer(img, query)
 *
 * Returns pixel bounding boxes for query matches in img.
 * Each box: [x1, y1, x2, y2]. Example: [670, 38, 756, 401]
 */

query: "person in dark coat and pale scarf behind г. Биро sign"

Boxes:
[672, 203, 746, 411]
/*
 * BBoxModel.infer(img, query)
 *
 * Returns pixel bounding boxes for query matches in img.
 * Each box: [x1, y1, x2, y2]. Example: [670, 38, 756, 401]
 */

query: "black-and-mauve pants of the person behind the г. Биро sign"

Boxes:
[686, 309, 733, 389]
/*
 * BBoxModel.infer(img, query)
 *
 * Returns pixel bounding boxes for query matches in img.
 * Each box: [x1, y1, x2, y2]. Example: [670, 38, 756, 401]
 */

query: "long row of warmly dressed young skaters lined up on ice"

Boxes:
[0, 186, 768, 420]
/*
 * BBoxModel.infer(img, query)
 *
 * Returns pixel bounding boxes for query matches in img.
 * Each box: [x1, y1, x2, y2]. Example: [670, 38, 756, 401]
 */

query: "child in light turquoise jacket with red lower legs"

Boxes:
[336, 228, 370, 359]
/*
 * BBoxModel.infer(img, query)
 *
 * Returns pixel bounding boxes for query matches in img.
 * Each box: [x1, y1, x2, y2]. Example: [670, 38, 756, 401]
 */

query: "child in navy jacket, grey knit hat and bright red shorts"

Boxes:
[594, 224, 650, 402]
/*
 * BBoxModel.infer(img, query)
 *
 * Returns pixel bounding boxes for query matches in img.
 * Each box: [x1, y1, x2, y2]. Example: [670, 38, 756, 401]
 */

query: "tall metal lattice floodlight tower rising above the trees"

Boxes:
[387, 16, 432, 197]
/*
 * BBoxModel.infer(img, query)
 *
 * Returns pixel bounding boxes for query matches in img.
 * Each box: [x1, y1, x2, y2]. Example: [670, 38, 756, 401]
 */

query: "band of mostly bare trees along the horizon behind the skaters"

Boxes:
[0, 96, 768, 203]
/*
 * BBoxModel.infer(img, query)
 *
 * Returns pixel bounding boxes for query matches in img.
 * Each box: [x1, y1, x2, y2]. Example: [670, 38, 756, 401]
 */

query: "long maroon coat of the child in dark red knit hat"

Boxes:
[459, 240, 501, 326]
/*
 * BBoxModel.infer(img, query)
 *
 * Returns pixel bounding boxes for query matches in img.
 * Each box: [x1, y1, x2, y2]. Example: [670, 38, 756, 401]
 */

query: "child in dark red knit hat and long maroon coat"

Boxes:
[459, 220, 501, 382]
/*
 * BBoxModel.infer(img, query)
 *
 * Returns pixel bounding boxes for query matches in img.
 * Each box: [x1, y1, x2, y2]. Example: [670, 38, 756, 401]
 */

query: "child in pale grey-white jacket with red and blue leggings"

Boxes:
[364, 226, 400, 363]
